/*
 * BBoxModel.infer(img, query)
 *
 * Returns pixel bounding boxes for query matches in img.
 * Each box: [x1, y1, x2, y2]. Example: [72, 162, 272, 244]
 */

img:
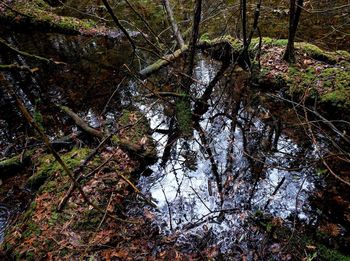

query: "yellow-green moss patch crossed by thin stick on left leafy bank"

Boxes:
[27, 148, 90, 191]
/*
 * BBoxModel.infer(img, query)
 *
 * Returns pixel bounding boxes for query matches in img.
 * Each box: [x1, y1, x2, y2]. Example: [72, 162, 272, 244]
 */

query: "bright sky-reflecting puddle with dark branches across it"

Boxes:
[139, 59, 315, 252]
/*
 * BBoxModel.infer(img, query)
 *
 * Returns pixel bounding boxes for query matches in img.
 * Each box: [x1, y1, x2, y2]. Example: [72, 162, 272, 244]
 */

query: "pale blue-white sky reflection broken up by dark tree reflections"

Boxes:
[140, 57, 314, 250]
